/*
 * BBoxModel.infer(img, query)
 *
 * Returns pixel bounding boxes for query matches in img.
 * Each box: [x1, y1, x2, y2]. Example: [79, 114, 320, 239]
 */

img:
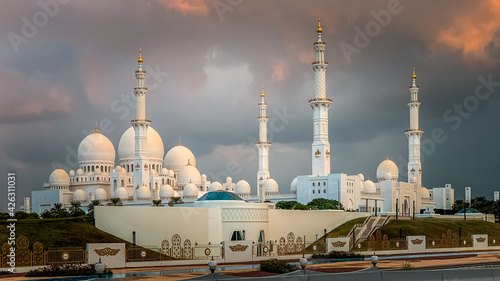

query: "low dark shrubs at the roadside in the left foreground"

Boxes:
[26, 264, 113, 277]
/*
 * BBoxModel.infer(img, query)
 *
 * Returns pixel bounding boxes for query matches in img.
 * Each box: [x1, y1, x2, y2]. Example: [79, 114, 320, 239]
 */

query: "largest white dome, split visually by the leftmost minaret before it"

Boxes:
[118, 126, 165, 162]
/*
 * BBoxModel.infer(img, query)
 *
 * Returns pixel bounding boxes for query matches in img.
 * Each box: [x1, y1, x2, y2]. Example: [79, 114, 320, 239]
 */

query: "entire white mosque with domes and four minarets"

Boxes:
[29, 19, 454, 215]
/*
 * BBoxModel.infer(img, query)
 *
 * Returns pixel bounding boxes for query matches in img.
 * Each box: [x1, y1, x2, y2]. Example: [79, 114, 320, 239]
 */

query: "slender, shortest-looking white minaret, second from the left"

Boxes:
[255, 87, 271, 202]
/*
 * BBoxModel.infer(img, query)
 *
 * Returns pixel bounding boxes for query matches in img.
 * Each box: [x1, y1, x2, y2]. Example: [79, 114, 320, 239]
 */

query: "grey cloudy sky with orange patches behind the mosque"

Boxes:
[0, 0, 500, 209]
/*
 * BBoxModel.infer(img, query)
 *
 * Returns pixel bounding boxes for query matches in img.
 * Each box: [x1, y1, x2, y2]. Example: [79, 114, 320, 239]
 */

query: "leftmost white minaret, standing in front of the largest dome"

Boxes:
[132, 50, 151, 200]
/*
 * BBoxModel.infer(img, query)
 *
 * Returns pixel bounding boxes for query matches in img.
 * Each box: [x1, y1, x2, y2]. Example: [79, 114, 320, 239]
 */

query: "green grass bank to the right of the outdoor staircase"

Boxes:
[379, 218, 500, 239]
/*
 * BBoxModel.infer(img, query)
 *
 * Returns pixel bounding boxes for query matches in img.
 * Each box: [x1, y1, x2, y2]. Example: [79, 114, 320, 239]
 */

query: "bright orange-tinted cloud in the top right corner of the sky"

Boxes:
[437, 0, 500, 58]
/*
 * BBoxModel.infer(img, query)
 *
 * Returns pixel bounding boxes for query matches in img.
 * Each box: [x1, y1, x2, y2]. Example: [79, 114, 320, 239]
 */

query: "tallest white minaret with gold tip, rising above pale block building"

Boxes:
[309, 18, 332, 176]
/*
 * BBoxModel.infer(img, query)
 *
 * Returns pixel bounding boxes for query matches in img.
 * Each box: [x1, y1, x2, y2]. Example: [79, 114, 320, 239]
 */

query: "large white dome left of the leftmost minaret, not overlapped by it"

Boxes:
[78, 132, 115, 163]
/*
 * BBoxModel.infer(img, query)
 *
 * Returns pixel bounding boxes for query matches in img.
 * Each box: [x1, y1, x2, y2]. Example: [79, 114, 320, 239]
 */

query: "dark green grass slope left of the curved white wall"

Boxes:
[0, 217, 131, 249]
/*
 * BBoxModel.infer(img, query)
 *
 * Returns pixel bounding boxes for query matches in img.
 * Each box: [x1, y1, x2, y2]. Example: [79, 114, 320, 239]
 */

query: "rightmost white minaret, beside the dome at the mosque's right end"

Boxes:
[405, 68, 424, 186]
